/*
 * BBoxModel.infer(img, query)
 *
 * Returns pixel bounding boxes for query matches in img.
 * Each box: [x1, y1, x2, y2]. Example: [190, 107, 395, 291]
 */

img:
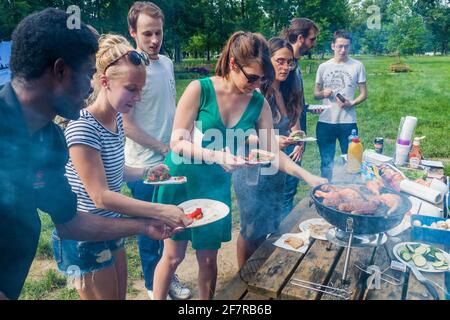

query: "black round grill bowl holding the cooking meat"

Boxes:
[310, 183, 411, 235]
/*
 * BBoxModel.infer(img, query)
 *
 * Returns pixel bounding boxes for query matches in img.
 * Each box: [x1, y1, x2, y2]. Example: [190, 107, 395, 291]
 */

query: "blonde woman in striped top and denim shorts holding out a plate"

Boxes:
[53, 35, 190, 300]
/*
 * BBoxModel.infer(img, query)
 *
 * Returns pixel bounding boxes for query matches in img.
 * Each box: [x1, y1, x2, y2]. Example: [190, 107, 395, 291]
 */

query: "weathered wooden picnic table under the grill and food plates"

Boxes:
[216, 198, 450, 300]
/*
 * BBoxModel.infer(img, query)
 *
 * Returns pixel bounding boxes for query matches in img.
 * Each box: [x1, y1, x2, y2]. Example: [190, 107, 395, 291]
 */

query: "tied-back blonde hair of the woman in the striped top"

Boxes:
[88, 34, 145, 104]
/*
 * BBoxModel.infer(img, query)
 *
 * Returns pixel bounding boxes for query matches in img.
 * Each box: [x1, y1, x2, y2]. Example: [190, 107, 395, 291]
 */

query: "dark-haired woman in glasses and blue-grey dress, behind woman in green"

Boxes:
[233, 38, 325, 268]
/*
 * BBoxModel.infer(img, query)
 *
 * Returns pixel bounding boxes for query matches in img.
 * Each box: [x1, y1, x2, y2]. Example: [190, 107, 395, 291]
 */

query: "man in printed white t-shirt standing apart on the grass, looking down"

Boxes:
[314, 30, 367, 181]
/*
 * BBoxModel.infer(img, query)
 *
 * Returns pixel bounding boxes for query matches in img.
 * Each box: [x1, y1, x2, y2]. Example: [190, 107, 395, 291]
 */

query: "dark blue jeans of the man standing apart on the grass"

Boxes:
[316, 122, 358, 181]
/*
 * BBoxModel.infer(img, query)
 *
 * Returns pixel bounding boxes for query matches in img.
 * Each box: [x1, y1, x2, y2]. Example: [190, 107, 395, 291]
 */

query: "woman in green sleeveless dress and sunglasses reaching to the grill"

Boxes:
[153, 32, 322, 300]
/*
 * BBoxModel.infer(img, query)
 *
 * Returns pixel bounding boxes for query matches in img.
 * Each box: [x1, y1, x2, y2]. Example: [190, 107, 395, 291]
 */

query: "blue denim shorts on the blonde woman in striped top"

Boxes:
[52, 230, 125, 277]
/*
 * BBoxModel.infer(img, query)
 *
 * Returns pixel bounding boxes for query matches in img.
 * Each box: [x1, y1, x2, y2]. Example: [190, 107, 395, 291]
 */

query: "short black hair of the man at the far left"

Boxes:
[11, 8, 98, 80]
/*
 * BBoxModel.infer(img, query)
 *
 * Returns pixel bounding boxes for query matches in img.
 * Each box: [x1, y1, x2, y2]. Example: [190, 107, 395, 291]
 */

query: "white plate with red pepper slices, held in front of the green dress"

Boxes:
[178, 199, 230, 228]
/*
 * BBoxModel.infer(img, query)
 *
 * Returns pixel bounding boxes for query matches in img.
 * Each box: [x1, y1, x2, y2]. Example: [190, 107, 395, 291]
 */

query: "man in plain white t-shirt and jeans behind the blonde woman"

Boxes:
[123, 1, 191, 299]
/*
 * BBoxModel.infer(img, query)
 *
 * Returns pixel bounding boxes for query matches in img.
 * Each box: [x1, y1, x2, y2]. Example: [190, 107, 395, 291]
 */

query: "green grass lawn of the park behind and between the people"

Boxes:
[21, 56, 450, 299]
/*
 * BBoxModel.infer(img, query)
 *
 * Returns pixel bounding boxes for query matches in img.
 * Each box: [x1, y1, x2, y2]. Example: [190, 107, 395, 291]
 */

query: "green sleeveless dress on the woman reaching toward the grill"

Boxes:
[155, 78, 264, 250]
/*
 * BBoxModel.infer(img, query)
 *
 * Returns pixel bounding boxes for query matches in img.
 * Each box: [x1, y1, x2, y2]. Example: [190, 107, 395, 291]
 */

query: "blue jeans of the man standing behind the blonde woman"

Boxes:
[127, 181, 163, 290]
